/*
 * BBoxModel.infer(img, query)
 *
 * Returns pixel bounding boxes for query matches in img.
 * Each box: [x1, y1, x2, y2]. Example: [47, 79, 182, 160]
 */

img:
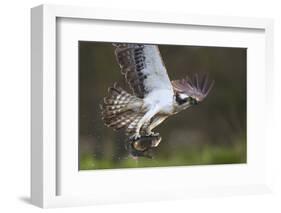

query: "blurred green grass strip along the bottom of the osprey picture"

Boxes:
[80, 139, 246, 170]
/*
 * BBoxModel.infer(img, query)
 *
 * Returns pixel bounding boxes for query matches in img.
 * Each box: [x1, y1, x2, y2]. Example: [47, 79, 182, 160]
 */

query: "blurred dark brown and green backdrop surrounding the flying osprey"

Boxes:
[79, 41, 247, 170]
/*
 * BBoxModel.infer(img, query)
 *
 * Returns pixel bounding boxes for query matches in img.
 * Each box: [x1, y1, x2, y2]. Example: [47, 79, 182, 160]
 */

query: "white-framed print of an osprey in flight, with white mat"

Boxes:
[31, 5, 273, 207]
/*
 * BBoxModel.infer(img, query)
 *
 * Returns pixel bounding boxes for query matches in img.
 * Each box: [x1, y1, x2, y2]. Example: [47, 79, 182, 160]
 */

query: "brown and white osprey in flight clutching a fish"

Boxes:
[101, 43, 214, 156]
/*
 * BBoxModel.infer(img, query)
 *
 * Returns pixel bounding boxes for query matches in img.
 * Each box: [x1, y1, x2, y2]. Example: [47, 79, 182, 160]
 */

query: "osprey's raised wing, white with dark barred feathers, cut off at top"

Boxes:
[113, 43, 173, 98]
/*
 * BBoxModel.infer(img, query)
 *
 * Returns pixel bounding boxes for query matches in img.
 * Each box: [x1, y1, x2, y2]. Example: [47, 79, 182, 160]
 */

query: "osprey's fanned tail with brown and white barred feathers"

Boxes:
[101, 84, 142, 130]
